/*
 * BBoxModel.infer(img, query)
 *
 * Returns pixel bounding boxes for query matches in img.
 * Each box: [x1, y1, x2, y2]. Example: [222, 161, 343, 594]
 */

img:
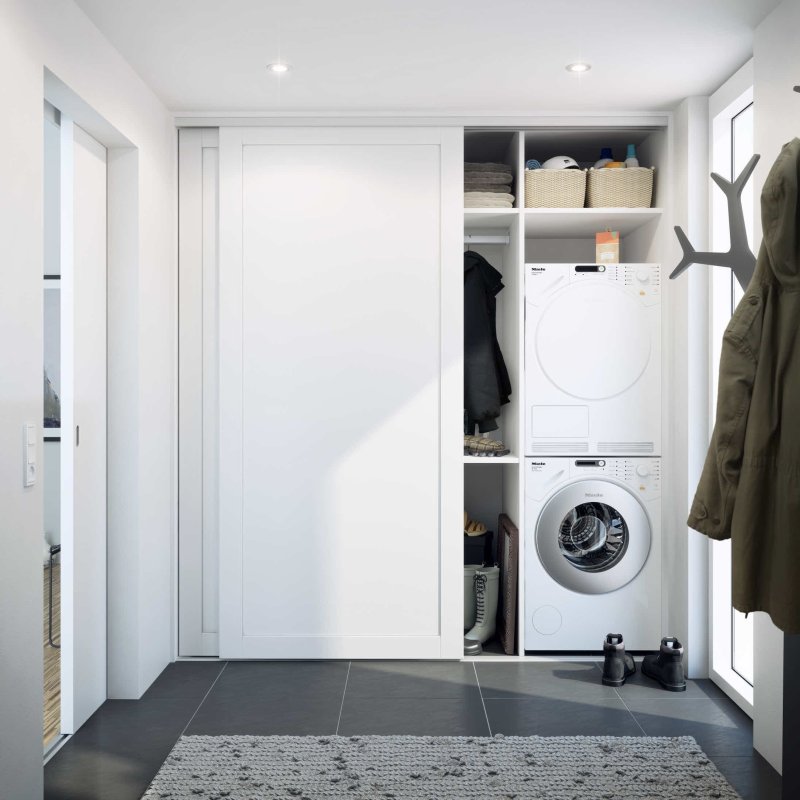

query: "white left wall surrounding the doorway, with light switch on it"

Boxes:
[0, 0, 175, 800]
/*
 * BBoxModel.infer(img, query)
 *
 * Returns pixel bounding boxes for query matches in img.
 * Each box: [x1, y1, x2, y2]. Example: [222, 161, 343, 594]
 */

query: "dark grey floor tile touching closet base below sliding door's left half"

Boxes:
[210, 661, 348, 702]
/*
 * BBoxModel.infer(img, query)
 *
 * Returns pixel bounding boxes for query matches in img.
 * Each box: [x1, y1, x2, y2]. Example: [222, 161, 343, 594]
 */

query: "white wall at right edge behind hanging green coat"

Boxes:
[753, 0, 800, 771]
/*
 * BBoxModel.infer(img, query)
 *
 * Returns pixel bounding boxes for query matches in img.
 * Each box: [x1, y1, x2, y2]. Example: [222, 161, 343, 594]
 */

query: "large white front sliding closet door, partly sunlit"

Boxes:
[219, 128, 463, 658]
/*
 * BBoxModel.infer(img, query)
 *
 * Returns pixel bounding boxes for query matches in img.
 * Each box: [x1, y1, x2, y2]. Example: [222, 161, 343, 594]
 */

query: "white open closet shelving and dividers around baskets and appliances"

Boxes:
[464, 122, 670, 661]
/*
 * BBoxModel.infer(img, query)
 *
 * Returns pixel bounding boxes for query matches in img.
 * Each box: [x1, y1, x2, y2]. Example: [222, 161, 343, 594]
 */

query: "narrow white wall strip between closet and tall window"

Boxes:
[664, 97, 708, 678]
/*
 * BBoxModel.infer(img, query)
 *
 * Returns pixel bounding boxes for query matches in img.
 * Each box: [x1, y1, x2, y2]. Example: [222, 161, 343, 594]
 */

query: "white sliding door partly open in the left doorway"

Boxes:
[61, 123, 107, 733]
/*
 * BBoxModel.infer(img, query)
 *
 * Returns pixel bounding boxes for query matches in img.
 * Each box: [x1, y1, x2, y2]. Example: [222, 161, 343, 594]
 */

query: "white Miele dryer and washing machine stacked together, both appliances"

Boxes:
[524, 264, 662, 652]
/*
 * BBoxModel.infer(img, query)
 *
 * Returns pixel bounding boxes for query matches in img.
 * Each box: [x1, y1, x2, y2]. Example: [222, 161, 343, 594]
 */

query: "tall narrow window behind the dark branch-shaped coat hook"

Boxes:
[711, 89, 756, 707]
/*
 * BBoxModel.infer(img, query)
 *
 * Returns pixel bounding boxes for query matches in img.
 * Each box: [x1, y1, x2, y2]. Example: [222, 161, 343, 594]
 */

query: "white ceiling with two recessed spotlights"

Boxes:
[76, 0, 779, 114]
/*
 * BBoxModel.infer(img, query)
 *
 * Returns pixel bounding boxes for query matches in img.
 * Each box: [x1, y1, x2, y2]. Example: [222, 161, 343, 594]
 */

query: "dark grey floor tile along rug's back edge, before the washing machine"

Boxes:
[484, 697, 643, 736]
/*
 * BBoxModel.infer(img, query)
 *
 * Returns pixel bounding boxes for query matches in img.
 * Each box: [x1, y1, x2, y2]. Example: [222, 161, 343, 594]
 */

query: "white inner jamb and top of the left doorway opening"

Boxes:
[44, 68, 147, 720]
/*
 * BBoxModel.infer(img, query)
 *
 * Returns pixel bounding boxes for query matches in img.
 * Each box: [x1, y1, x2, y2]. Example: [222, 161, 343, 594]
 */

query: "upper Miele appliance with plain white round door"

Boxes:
[525, 264, 661, 456]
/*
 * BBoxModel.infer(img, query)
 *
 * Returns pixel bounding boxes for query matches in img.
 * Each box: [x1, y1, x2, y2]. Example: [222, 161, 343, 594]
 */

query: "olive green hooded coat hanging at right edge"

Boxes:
[689, 139, 800, 633]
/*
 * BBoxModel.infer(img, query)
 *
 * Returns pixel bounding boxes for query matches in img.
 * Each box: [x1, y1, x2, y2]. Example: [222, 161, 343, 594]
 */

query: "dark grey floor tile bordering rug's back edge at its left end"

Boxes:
[186, 692, 344, 736]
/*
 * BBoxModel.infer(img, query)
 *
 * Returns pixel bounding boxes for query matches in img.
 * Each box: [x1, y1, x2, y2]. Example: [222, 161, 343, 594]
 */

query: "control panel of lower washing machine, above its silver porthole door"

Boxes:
[526, 456, 661, 501]
